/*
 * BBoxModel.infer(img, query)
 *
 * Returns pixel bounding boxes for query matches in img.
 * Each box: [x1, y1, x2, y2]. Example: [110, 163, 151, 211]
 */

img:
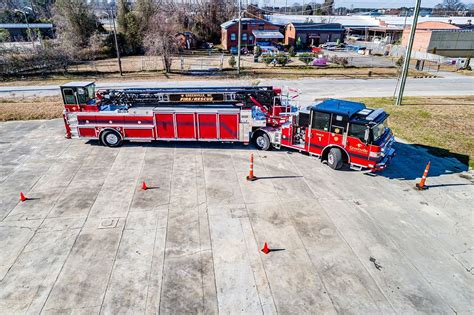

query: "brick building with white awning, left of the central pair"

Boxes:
[221, 18, 283, 50]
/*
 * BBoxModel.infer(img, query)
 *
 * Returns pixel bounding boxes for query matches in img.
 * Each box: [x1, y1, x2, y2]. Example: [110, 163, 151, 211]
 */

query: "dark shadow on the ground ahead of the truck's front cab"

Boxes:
[377, 142, 472, 183]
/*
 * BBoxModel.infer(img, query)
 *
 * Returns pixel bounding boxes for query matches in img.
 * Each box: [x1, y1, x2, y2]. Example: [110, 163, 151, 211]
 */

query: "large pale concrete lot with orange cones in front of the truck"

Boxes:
[0, 120, 474, 314]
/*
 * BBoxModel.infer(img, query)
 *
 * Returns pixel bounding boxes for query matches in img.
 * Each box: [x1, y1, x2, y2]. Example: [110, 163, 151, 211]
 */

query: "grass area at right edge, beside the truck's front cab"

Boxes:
[348, 96, 474, 167]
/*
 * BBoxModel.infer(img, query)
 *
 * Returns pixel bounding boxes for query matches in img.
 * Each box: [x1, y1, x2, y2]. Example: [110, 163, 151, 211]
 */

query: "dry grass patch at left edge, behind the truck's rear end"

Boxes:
[0, 96, 64, 121]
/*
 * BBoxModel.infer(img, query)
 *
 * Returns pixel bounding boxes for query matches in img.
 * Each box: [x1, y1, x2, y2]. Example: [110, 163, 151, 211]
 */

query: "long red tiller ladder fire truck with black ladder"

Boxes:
[61, 82, 395, 171]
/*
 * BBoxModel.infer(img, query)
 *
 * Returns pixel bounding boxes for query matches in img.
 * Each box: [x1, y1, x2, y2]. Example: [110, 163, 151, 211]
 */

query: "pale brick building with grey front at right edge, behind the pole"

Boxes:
[402, 22, 474, 57]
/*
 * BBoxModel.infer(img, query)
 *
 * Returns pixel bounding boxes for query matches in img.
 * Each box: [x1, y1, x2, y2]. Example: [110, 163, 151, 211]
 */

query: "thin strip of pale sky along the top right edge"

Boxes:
[259, 0, 474, 8]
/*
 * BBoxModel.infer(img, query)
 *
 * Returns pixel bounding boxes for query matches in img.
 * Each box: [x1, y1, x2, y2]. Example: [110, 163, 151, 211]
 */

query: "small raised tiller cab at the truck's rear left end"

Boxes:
[61, 82, 98, 112]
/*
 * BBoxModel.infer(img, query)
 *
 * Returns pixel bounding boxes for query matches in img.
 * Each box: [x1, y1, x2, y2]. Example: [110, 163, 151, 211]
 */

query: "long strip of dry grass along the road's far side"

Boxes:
[2, 55, 436, 86]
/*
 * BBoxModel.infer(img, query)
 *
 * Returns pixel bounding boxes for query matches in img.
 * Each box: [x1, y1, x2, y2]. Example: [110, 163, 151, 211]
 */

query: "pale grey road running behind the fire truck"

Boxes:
[0, 75, 474, 102]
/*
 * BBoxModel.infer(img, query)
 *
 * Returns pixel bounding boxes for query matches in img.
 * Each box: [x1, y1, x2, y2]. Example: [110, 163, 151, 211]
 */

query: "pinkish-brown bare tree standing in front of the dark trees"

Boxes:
[143, 7, 179, 73]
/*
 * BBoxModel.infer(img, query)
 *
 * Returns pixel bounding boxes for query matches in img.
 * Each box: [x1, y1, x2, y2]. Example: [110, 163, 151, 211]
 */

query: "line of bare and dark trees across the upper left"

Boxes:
[0, 0, 237, 75]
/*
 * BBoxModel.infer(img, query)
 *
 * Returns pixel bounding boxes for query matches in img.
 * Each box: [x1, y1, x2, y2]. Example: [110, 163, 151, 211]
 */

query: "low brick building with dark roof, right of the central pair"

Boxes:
[285, 23, 345, 48]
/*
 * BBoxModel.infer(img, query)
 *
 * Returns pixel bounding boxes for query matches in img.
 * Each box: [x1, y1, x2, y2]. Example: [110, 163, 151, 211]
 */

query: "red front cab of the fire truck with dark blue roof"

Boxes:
[298, 99, 395, 170]
